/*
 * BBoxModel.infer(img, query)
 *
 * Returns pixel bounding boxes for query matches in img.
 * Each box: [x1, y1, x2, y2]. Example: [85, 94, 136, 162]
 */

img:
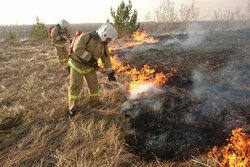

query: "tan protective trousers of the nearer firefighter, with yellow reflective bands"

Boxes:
[68, 64, 100, 111]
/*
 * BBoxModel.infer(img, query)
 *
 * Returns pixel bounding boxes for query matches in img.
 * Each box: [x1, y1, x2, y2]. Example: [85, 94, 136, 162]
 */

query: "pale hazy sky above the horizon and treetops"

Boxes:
[0, 0, 247, 25]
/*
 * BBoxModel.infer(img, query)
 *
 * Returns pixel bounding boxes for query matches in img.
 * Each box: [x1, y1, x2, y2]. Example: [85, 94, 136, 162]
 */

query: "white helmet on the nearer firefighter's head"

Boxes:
[97, 23, 118, 41]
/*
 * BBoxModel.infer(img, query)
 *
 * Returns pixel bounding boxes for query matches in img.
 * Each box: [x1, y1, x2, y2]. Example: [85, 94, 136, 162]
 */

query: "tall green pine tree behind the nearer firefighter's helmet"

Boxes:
[110, 0, 140, 36]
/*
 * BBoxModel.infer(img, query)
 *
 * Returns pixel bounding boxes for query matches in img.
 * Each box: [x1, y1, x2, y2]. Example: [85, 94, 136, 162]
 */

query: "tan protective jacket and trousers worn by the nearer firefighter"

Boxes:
[68, 32, 113, 110]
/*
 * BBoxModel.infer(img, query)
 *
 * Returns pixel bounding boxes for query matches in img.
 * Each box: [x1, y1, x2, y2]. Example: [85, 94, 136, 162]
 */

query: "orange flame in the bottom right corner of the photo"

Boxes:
[208, 128, 250, 167]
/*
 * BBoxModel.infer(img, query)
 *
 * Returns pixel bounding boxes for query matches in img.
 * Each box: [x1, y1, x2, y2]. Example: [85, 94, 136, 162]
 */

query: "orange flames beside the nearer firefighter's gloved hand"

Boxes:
[111, 56, 177, 89]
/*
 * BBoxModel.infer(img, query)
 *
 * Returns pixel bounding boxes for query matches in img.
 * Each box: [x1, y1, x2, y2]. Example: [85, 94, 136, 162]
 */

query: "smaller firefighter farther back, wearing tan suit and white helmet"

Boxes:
[51, 19, 71, 64]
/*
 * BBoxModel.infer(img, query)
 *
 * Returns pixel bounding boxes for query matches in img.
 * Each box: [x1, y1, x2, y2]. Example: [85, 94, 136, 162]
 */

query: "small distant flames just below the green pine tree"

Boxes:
[127, 31, 159, 47]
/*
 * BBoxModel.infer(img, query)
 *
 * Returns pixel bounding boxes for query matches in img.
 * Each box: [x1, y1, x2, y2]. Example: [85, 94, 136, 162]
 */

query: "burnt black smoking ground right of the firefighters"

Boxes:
[119, 29, 250, 160]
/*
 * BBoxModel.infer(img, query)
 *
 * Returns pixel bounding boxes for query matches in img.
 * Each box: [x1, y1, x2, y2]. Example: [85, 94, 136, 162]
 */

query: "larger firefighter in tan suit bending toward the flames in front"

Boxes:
[68, 23, 118, 116]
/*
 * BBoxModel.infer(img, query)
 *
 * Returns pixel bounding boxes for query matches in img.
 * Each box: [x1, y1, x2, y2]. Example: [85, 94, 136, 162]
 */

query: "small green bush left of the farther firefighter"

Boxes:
[30, 17, 48, 40]
